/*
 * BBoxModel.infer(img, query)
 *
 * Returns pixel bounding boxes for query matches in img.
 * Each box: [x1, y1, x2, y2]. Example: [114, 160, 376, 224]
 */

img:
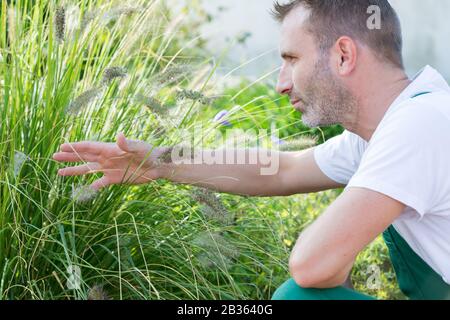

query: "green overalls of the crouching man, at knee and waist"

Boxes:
[272, 226, 450, 300]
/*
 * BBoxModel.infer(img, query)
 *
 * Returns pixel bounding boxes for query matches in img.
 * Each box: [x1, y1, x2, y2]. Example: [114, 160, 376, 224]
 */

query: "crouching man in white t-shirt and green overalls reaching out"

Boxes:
[54, 0, 450, 299]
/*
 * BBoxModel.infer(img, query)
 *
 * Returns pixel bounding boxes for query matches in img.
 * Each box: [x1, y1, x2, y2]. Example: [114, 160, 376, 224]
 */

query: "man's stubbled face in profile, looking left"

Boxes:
[277, 7, 356, 128]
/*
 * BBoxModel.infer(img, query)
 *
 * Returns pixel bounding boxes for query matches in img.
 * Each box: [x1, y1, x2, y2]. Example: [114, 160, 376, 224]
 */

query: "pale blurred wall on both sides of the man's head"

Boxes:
[202, 0, 450, 81]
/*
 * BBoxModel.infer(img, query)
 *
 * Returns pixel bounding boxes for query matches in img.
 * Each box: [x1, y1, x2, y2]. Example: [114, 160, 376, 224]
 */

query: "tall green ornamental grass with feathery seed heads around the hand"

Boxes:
[0, 0, 298, 299]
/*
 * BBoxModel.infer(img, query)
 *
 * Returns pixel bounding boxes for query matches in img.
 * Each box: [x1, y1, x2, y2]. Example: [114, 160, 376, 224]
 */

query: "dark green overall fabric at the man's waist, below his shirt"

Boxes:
[383, 226, 450, 300]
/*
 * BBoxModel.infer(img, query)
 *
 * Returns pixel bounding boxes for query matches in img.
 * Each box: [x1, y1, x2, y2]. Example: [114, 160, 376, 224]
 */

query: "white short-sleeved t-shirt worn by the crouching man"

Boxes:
[314, 66, 450, 284]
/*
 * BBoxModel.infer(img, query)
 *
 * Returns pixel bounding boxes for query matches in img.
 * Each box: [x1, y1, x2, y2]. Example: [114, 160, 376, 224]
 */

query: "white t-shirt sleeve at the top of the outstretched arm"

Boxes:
[314, 130, 366, 185]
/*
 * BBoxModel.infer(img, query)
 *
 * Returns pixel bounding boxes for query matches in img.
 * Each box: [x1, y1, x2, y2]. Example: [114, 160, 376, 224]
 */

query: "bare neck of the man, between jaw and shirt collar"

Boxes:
[343, 71, 412, 142]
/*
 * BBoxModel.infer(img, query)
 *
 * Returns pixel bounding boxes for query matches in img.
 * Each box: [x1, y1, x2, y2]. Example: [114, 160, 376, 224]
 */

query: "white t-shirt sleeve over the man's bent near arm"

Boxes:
[347, 105, 450, 217]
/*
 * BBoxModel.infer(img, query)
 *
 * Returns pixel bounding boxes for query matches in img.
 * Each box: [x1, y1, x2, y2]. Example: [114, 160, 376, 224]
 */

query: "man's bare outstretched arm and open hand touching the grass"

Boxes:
[53, 134, 341, 196]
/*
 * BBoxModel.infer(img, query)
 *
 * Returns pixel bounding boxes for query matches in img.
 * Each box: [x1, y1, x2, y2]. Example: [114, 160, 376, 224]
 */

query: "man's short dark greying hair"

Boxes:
[272, 0, 404, 69]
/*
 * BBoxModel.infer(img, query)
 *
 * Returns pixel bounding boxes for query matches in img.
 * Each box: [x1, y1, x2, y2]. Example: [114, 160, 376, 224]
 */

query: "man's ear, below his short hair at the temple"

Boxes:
[333, 36, 358, 76]
